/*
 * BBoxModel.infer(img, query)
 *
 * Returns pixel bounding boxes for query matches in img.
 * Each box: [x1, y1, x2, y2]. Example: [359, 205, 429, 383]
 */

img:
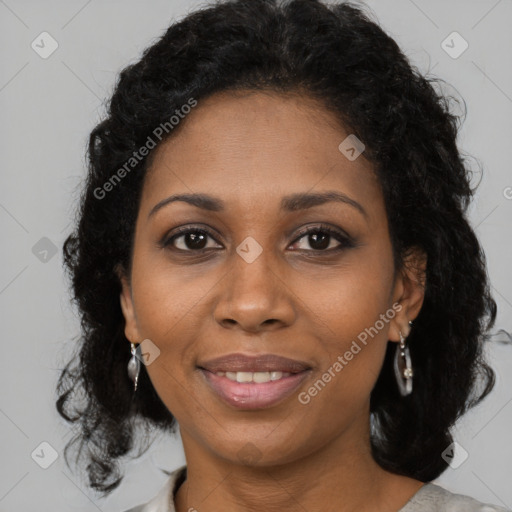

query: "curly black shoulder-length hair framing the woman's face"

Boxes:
[57, 0, 496, 494]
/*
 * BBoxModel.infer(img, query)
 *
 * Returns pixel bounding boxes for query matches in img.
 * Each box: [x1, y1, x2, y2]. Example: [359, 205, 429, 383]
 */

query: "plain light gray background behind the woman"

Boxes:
[0, 0, 512, 512]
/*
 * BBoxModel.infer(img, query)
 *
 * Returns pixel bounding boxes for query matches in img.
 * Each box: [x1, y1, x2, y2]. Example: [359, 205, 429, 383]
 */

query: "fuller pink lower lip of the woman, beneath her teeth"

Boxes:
[200, 368, 310, 409]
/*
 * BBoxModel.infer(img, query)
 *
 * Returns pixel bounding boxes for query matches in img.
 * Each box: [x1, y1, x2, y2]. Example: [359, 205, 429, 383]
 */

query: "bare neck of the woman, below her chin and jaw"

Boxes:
[175, 422, 423, 512]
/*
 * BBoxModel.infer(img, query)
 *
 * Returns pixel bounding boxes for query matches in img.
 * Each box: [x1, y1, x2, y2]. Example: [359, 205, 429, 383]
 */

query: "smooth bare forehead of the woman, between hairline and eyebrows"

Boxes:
[143, 91, 381, 215]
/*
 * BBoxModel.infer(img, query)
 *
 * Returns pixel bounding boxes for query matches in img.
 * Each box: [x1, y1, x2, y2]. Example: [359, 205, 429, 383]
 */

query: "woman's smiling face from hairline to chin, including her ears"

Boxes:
[121, 92, 423, 465]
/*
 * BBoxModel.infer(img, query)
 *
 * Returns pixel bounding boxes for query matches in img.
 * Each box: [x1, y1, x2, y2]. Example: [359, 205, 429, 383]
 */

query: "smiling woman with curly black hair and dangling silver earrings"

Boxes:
[57, 0, 505, 512]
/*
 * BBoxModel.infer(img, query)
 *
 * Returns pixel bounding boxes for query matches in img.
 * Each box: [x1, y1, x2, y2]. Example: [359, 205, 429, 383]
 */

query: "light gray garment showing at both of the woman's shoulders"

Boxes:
[125, 465, 512, 512]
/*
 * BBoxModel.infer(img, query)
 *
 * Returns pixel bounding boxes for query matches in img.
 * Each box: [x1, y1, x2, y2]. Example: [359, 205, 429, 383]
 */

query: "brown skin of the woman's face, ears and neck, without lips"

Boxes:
[120, 91, 425, 512]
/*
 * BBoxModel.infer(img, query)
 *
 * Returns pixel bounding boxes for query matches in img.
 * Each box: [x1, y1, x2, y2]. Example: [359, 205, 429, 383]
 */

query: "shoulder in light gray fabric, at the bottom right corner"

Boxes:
[399, 483, 512, 512]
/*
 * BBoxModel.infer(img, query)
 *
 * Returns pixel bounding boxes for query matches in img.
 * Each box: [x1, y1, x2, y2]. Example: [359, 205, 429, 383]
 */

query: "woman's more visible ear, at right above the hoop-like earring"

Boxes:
[388, 246, 427, 342]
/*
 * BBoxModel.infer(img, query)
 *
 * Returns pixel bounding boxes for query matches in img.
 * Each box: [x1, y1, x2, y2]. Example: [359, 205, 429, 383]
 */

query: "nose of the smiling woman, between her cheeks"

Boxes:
[214, 242, 296, 333]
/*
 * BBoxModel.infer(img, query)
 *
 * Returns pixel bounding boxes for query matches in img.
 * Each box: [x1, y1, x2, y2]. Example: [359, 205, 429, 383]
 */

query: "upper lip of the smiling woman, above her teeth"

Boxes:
[198, 353, 311, 373]
